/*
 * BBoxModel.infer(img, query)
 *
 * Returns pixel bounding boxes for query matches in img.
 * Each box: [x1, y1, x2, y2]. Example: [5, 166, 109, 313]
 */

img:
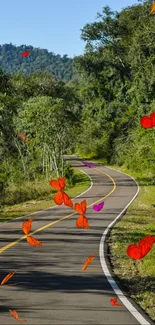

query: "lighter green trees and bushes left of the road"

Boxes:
[0, 70, 82, 204]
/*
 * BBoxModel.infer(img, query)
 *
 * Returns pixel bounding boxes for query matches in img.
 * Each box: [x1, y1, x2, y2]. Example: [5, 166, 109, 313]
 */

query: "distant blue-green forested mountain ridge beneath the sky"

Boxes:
[0, 43, 73, 81]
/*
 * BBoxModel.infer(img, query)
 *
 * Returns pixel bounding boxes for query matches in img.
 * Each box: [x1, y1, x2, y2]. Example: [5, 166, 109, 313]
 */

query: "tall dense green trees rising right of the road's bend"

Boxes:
[75, 1, 155, 176]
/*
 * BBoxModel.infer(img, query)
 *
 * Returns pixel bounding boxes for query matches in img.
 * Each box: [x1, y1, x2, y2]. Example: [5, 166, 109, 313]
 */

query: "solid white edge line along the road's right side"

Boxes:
[99, 165, 151, 325]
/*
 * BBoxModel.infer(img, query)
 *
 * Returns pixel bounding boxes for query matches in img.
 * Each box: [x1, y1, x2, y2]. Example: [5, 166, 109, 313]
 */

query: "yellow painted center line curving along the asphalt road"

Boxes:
[0, 168, 116, 254]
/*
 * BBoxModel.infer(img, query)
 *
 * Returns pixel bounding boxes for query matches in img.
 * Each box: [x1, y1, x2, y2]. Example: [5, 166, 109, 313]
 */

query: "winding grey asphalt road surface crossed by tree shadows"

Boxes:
[0, 157, 153, 325]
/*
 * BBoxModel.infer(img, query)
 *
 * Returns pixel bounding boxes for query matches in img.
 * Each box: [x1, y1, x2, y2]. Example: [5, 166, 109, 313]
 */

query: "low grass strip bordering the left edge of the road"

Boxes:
[0, 170, 90, 222]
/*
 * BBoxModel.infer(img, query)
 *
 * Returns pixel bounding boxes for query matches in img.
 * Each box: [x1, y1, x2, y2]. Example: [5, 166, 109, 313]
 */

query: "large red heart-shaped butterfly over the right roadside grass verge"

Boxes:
[126, 235, 155, 260]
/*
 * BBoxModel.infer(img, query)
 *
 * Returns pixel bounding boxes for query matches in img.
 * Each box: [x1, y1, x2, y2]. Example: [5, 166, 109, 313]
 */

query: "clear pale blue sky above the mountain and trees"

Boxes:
[0, 0, 138, 57]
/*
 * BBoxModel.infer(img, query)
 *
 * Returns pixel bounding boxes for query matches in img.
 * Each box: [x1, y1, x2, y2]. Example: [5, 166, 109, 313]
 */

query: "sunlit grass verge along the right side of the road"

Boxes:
[76, 157, 155, 320]
